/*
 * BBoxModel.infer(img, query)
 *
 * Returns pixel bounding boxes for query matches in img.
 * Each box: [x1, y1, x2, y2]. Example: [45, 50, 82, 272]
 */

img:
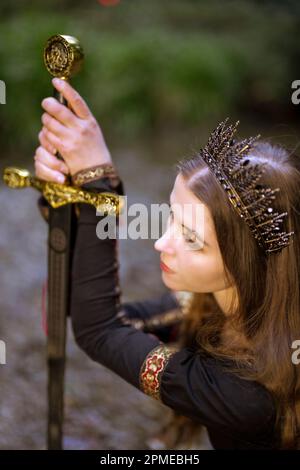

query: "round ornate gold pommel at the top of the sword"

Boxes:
[44, 34, 84, 79]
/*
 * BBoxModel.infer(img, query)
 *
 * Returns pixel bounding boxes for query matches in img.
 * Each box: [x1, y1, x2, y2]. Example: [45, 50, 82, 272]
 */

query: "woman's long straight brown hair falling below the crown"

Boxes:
[176, 141, 300, 449]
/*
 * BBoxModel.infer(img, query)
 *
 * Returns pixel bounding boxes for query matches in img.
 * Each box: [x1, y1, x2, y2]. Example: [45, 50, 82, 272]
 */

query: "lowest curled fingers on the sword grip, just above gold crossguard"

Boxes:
[34, 147, 69, 183]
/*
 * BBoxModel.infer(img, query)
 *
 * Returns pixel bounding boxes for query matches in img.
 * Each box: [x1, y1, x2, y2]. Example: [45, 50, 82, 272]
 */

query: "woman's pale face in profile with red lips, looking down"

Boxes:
[154, 174, 229, 292]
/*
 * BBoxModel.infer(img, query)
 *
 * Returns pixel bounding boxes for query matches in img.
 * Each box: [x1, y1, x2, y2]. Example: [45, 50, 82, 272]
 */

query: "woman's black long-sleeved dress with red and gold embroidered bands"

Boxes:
[40, 178, 278, 449]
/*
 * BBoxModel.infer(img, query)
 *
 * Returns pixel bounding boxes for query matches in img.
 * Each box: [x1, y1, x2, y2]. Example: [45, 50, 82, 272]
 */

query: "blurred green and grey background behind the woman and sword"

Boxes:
[0, 0, 300, 449]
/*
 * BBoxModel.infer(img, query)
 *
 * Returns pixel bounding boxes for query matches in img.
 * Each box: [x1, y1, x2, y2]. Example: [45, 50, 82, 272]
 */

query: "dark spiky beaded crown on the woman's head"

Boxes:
[199, 118, 294, 253]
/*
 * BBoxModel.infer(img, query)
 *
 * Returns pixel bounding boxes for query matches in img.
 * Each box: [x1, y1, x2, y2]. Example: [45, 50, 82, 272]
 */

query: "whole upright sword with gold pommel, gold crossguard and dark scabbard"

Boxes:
[3, 35, 124, 450]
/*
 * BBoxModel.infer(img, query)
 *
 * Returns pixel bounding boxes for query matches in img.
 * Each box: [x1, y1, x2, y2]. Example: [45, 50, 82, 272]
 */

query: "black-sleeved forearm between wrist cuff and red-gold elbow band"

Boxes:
[71, 175, 169, 387]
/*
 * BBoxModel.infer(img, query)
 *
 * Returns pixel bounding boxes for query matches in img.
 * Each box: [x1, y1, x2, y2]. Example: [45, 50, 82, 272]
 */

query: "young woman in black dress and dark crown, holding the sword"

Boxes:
[35, 80, 300, 449]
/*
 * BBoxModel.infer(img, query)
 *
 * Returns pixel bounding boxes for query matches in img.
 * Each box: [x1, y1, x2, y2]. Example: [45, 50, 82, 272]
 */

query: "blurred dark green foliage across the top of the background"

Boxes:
[0, 0, 299, 153]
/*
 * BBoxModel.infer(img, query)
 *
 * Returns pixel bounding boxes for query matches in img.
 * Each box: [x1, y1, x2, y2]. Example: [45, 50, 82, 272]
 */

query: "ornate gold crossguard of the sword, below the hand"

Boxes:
[3, 167, 124, 215]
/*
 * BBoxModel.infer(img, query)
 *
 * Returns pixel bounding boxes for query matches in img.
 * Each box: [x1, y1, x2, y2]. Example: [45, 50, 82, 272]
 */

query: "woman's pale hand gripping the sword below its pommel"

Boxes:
[34, 79, 112, 183]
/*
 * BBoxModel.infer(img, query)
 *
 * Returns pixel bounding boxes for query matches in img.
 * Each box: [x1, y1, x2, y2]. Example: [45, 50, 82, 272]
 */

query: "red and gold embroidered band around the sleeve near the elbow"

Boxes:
[140, 344, 178, 401]
